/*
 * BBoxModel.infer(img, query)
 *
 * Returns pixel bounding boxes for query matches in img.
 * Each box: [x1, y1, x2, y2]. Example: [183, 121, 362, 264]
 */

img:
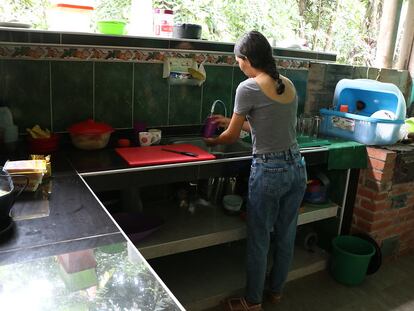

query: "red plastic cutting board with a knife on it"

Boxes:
[115, 144, 216, 166]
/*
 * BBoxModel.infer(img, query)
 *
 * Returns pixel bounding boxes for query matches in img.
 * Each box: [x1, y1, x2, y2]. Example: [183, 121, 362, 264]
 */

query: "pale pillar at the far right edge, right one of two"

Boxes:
[395, 0, 414, 70]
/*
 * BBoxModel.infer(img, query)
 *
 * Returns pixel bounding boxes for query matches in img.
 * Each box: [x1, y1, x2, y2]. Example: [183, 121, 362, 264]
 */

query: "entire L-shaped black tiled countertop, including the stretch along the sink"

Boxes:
[0, 138, 364, 310]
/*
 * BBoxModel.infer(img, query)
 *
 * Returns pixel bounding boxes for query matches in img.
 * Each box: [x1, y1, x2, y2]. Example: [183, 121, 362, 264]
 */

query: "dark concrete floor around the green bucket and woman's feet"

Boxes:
[211, 253, 414, 311]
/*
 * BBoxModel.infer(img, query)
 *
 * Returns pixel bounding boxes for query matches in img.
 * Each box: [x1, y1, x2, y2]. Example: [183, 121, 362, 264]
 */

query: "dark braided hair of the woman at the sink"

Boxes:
[234, 31, 285, 94]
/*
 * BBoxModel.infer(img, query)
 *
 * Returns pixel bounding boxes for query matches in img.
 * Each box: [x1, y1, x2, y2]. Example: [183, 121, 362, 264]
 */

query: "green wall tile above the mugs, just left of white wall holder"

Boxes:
[134, 63, 168, 126]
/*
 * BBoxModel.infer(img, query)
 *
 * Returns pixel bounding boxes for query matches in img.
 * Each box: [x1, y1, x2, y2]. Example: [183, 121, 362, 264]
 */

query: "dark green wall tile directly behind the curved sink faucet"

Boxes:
[201, 66, 233, 121]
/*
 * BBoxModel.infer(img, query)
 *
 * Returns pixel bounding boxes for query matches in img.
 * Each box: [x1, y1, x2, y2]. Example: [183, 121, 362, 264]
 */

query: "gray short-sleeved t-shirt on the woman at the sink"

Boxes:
[234, 78, 298, 154]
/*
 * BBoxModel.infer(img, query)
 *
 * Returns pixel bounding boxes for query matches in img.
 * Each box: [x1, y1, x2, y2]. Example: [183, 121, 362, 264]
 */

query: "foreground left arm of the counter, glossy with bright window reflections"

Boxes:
[0, 154, 183, 310]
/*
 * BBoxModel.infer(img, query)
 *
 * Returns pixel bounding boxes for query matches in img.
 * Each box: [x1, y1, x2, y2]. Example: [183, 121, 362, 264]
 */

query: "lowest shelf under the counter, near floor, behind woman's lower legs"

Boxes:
[149, 241, 328, 310]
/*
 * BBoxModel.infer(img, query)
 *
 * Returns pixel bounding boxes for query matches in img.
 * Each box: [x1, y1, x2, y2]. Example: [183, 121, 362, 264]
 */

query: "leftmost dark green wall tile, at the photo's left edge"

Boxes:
[0, 60, 51, 132]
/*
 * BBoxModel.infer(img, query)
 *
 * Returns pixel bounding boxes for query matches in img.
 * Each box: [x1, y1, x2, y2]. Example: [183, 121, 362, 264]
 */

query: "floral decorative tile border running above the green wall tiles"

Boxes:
[0, 45, 309, 70]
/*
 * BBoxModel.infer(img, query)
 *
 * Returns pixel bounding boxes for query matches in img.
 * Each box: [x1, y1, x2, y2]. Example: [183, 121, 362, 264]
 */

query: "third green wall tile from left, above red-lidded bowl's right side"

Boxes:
[95, 62, 134, 128]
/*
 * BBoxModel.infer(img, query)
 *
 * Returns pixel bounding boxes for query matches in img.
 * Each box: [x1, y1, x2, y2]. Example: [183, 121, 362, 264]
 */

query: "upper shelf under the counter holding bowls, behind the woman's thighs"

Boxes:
[135, 202, 339, 259]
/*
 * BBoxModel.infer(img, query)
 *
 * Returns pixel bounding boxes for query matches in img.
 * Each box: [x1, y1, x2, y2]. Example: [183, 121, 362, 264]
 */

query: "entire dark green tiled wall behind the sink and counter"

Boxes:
[0, 60, 308, 132]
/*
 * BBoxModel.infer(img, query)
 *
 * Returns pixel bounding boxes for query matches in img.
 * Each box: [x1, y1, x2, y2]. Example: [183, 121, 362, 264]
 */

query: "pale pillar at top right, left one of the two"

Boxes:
[374, 0, 403, 68]
